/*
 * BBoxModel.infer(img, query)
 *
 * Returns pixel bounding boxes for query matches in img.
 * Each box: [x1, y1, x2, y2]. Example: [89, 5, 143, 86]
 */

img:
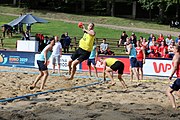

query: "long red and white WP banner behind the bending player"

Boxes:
[81, 56, 173, 76]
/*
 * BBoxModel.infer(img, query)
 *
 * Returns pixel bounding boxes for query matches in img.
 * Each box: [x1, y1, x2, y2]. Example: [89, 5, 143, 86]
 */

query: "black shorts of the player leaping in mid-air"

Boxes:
[71, 48, 91, 62]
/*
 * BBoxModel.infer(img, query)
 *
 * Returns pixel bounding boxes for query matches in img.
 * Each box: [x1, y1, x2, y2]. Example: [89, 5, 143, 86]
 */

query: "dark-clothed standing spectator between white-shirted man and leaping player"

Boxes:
[63, 32, 71, 53]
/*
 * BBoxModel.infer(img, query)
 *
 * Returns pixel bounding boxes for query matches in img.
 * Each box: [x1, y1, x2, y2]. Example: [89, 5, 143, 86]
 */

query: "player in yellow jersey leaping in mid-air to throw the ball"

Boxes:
[66, 23, 95, 80]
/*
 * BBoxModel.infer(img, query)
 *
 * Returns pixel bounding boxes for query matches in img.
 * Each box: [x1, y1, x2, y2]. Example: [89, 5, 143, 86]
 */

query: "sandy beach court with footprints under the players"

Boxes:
[0, 66, 180, 120]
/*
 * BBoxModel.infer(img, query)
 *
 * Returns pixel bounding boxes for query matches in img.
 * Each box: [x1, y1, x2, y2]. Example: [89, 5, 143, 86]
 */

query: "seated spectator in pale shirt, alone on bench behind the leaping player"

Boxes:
[98, 38, 109, 55]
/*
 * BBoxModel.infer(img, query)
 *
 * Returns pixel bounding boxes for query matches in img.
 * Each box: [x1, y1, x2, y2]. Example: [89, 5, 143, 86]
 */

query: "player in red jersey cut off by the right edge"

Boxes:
[166, 45, 180, 109]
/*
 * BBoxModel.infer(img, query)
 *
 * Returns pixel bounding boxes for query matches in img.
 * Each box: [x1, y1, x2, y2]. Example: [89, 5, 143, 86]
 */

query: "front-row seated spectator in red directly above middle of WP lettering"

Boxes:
[159, 41, 169, 58]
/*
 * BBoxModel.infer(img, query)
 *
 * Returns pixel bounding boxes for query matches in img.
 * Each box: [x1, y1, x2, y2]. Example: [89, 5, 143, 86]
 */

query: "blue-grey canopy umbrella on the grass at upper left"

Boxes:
[8, 14, 48, 27]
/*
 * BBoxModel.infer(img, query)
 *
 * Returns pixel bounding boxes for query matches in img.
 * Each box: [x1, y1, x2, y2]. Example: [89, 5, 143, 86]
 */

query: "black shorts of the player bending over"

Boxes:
[110, 61, 124, 75]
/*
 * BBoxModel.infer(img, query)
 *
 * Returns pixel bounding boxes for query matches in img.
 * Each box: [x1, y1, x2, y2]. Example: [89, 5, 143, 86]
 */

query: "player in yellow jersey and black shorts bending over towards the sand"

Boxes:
[100, 58, 127, 88]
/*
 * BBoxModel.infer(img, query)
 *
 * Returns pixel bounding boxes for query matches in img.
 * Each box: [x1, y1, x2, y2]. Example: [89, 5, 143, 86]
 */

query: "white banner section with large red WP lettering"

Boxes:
[143, 59, 173, 76]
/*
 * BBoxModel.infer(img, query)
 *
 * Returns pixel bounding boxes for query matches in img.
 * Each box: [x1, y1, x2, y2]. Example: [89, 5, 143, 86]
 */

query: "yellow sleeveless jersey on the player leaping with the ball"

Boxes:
[79, 33, 95, 52]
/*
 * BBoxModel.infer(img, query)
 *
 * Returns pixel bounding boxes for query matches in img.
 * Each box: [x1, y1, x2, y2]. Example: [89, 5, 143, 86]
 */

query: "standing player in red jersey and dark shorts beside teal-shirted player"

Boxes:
[136, 40, 146, 80]
